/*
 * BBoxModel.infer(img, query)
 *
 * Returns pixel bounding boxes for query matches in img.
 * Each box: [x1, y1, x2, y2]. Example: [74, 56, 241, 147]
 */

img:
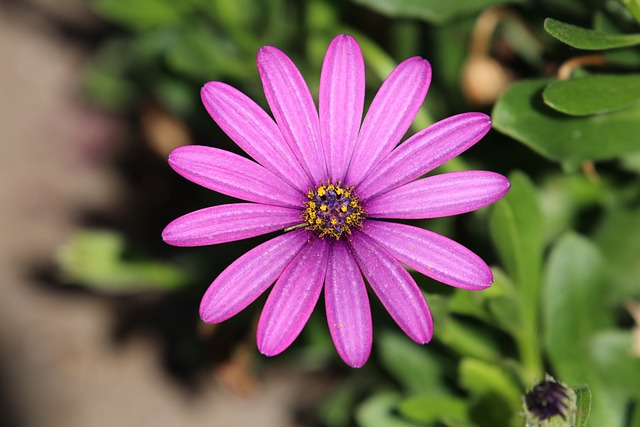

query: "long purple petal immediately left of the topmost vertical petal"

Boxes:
[258, 46, 327, 184]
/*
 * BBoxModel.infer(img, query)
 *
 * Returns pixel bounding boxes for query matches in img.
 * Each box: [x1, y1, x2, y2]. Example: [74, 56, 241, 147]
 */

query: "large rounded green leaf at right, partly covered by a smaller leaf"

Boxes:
[491, 79, 640, 167]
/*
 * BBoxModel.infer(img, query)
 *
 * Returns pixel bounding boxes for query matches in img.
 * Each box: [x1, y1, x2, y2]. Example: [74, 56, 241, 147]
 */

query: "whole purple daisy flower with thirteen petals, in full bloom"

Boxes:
[162, 35, 509, 367]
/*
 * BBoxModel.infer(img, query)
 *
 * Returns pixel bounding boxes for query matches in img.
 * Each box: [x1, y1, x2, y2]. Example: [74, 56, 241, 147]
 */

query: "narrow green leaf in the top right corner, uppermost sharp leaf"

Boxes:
[544, 18, 640, 50]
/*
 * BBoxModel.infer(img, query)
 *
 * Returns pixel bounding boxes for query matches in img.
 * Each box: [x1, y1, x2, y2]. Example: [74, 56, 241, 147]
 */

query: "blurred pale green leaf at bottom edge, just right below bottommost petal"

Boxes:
[355, 392, 415, 427]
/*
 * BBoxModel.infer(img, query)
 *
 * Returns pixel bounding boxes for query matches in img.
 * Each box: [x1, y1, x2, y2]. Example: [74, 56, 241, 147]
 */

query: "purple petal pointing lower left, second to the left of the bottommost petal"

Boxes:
[200, 230, 309, 323]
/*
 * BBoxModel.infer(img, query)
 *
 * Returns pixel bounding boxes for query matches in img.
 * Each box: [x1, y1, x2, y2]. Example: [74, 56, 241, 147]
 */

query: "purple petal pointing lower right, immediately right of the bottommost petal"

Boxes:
[349, 231, 433, 344]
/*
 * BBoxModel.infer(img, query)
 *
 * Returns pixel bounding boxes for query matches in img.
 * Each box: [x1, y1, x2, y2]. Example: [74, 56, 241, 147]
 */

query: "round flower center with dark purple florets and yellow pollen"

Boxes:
[304, 181, 364, 240]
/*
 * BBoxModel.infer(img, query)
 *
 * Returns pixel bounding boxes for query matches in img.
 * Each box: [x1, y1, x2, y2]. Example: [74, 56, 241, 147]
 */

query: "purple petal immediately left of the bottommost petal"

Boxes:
[257, 239, 329, 356]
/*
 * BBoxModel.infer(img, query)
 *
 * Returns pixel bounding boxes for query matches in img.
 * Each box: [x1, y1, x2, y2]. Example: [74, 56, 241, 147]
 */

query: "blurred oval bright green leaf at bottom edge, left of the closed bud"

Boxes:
[398, 396, 469, 425]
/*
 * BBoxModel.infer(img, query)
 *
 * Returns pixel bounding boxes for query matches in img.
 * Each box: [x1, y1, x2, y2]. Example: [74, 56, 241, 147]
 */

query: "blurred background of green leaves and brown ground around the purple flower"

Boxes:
[0, 0, 640, 427]
